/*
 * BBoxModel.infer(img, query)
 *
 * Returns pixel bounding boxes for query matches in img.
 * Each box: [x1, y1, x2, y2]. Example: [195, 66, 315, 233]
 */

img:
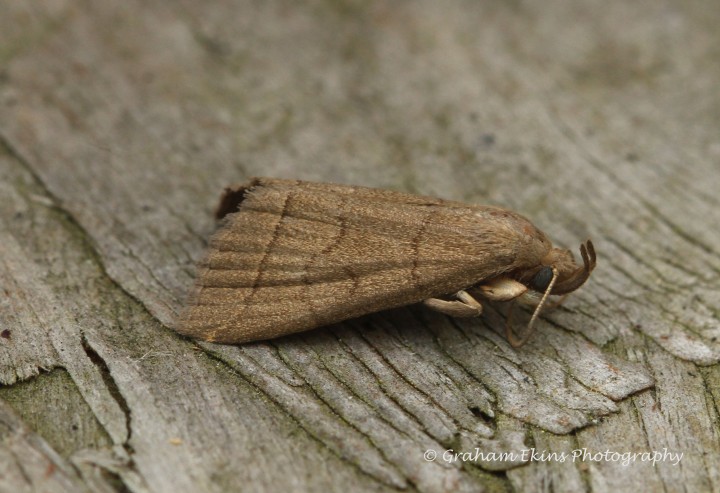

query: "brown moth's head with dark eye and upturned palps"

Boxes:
[528, 240, 597, 295]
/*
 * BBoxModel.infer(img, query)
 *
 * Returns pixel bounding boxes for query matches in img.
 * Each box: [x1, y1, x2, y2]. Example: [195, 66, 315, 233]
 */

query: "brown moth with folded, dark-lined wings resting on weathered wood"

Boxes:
[175, 178, 596, 347]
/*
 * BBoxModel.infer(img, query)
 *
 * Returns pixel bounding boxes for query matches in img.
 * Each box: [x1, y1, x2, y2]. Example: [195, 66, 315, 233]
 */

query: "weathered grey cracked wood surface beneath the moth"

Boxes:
[0, 0, 720, 492]
